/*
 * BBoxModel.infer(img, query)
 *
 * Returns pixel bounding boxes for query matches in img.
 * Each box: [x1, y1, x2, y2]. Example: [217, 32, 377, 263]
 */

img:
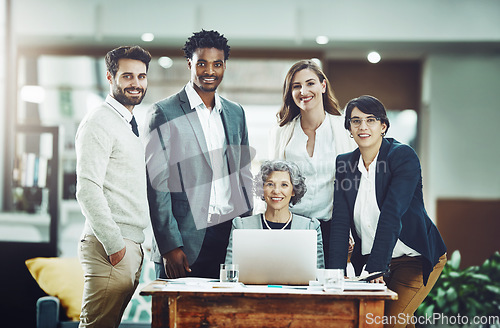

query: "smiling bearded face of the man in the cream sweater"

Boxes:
[106, 58, 148, 112]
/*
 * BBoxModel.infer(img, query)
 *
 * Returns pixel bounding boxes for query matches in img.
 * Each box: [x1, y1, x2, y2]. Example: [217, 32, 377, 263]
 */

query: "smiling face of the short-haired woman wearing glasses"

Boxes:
[349, 107, 387, 149]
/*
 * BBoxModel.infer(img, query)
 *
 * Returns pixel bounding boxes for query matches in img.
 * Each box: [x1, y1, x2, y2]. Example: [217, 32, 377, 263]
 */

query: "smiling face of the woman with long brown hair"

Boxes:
[291, 68, 326, 111]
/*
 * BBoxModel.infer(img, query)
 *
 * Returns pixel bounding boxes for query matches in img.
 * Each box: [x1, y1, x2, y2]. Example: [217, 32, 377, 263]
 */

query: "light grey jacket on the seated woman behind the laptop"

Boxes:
[225, 214, 325, 269]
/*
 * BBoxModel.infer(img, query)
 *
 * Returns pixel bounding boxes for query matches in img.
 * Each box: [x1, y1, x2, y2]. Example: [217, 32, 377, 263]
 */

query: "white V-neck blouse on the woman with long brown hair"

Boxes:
[285, 118, 337, 221]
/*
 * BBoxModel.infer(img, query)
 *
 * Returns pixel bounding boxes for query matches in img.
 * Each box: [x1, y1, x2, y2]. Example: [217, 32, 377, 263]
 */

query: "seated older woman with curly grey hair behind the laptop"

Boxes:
[226, 160, 325, 268]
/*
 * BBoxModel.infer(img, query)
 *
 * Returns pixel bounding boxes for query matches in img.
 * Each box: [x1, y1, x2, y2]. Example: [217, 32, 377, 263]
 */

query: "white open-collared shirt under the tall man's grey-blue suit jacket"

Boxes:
[186, 82, 233, 219]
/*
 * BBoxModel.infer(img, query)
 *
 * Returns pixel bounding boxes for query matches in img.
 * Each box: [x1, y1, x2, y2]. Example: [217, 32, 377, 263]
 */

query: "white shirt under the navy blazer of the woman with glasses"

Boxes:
[354, 154, 420, 258]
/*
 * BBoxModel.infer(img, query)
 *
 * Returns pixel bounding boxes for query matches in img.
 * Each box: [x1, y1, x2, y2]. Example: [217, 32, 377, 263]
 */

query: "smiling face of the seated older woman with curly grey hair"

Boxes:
[263, 171, 295, 211]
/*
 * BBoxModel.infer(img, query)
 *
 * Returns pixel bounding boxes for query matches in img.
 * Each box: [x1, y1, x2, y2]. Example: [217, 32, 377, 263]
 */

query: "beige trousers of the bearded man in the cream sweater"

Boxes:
[78, 235, 144, 328]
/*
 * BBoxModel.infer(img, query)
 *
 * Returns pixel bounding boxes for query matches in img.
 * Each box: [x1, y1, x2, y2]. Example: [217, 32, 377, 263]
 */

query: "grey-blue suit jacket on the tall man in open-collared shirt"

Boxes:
[142, 89, 252, 264]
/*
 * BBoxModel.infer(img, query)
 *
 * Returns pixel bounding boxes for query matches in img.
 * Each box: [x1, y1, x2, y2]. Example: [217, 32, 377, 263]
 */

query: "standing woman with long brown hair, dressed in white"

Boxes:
[269, 60, 356, 261]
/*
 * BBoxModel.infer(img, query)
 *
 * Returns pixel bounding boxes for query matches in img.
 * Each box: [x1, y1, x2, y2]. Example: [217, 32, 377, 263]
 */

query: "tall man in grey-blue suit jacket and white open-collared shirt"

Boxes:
[143, 30, 252, 278]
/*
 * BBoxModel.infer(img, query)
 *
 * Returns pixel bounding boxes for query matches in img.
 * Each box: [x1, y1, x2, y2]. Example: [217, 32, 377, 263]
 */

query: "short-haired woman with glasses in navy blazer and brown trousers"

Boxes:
[330, 96, 446, 327]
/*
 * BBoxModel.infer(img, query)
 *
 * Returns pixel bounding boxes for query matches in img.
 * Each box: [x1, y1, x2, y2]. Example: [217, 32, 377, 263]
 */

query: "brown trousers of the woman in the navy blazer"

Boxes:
[384, 253, 446, 328]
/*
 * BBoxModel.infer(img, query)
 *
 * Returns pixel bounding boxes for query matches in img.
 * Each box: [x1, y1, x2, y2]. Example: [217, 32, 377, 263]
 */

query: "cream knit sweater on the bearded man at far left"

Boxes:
[75, 98, 150, 255]
